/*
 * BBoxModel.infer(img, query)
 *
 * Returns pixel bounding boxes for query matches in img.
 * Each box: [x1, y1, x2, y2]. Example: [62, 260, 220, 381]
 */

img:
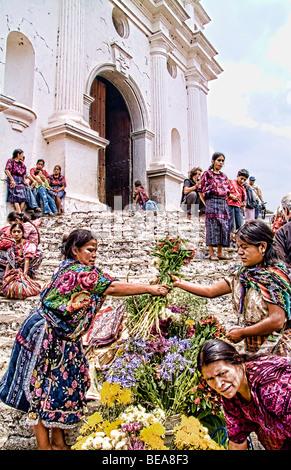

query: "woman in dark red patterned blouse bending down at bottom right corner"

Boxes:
[197, 339, 291, 450]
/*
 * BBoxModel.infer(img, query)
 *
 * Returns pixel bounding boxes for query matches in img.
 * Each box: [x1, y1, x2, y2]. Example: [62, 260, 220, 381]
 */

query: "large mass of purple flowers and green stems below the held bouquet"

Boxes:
[103, 316, 224, 416]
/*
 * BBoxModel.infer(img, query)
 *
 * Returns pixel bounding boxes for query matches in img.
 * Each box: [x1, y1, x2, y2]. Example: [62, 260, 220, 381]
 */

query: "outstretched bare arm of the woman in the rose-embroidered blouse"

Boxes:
[105, 281, 171, 297]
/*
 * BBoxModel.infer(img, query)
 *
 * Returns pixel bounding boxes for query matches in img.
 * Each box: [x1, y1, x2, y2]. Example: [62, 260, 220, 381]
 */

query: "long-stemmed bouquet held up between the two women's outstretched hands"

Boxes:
[127, 236, 195, 339]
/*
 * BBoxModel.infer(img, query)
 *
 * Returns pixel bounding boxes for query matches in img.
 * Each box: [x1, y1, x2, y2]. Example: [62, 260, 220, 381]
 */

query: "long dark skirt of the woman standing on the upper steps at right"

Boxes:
[205, 196, 230, 246]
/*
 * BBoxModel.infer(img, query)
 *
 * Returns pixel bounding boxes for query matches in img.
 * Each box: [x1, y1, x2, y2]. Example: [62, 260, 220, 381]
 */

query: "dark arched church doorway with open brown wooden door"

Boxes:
[89, 75, 132, 209]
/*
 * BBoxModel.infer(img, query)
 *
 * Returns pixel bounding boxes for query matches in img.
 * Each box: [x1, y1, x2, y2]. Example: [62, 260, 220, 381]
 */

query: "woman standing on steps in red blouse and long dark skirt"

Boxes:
[198, 152, 230, 261]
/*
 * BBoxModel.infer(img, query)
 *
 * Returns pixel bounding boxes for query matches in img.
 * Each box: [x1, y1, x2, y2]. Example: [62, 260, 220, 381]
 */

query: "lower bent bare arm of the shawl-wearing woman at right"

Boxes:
[226, 302, 286, 343]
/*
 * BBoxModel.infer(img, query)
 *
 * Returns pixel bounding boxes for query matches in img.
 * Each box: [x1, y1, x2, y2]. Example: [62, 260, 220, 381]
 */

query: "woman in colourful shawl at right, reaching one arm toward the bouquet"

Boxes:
[173, 220, 291, 356]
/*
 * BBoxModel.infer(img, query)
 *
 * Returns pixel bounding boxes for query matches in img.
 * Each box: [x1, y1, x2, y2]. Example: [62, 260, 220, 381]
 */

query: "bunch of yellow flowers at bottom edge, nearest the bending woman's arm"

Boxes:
[174, 416, 224, 450]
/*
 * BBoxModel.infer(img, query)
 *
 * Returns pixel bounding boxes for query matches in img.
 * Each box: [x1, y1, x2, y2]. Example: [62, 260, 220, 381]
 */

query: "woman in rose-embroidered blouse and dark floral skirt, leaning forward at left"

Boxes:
[0, 229, 169, 449]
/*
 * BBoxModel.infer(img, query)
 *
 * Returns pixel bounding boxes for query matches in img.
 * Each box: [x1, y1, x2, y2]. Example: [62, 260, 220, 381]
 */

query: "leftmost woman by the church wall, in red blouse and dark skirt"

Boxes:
[5, 149, 27, 212]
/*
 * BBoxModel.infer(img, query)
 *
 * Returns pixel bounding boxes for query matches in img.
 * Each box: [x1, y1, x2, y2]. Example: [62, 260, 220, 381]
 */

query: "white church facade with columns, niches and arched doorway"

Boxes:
[0, 0, 222, 219]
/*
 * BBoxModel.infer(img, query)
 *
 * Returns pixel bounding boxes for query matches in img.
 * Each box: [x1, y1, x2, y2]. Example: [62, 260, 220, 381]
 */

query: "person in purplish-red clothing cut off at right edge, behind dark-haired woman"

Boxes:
[274, 193, 291, 268]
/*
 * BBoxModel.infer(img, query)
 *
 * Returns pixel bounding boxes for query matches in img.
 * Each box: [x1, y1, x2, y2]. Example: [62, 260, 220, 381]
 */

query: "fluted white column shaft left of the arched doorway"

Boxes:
[51, 0, 88, 127]
